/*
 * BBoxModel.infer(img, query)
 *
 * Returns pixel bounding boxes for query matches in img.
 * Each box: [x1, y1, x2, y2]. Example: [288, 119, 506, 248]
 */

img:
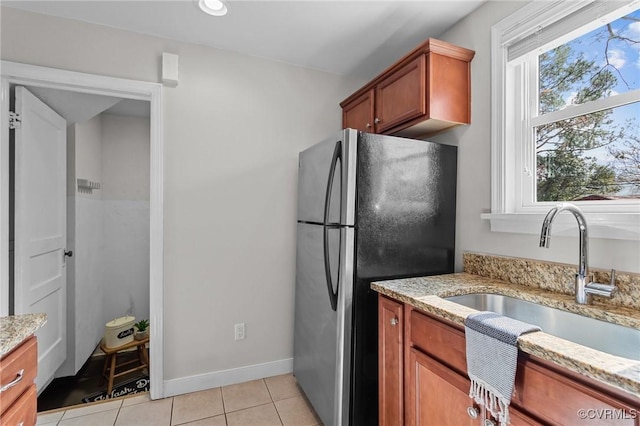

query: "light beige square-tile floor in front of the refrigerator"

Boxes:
[37, 374, 321, 426]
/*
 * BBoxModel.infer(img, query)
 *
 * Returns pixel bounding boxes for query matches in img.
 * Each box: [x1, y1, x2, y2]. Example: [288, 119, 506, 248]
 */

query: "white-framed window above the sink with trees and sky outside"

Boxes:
[483, 0, 640, 239]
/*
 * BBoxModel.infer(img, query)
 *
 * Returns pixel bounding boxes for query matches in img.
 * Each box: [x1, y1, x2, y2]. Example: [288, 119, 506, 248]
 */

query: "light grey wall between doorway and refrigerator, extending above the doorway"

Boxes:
[0, 7, 363, 386]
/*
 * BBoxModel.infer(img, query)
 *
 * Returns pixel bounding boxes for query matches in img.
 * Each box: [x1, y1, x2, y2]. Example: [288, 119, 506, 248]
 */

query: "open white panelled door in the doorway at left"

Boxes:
[14, 87, 67, 392]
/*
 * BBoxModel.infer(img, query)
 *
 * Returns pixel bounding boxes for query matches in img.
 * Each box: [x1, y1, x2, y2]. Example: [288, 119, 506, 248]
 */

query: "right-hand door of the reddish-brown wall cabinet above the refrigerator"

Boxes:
[374, 55, 427, 133]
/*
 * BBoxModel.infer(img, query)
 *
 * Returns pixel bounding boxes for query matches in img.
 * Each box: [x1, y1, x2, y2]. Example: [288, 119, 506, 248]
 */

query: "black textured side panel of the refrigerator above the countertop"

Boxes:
[356, 134, 457, 280]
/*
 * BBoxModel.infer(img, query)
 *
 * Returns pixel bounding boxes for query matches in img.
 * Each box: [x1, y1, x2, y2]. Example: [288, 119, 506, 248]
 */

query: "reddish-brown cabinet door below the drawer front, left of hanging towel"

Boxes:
[406, 348, 482, 426]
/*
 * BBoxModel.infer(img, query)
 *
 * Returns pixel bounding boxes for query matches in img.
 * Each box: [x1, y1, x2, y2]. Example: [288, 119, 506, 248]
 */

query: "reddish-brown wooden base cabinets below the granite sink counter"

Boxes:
[378, 295, 640, 426]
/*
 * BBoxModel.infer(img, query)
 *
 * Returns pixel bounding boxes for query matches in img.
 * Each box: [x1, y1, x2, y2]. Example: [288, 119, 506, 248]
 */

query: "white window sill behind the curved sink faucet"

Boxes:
[480, 211, 640, 240]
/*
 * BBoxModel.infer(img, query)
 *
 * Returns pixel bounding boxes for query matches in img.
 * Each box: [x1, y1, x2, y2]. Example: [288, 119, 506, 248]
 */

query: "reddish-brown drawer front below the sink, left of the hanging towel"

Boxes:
[411, 311, 467, 376]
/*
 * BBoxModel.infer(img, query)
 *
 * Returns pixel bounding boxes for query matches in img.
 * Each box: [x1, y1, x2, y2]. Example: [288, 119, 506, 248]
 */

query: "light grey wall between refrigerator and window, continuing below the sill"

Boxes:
[432, 1, 640, 272]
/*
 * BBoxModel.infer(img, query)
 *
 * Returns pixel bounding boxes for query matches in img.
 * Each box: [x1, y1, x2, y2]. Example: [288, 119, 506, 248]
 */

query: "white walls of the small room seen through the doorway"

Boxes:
[56, 110, 149, 377]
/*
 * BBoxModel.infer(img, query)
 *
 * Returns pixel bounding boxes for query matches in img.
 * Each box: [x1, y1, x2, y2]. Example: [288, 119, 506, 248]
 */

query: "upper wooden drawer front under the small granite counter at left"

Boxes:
[0, 337, 38, 412]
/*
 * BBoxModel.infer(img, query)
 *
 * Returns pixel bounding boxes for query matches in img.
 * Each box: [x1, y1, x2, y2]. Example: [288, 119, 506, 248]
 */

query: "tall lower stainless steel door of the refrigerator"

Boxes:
[293, 223, 354, 425]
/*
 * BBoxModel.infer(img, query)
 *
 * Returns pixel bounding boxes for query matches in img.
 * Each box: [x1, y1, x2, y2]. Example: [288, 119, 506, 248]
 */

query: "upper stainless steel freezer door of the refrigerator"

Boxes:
[298, 129, 358, 225]
